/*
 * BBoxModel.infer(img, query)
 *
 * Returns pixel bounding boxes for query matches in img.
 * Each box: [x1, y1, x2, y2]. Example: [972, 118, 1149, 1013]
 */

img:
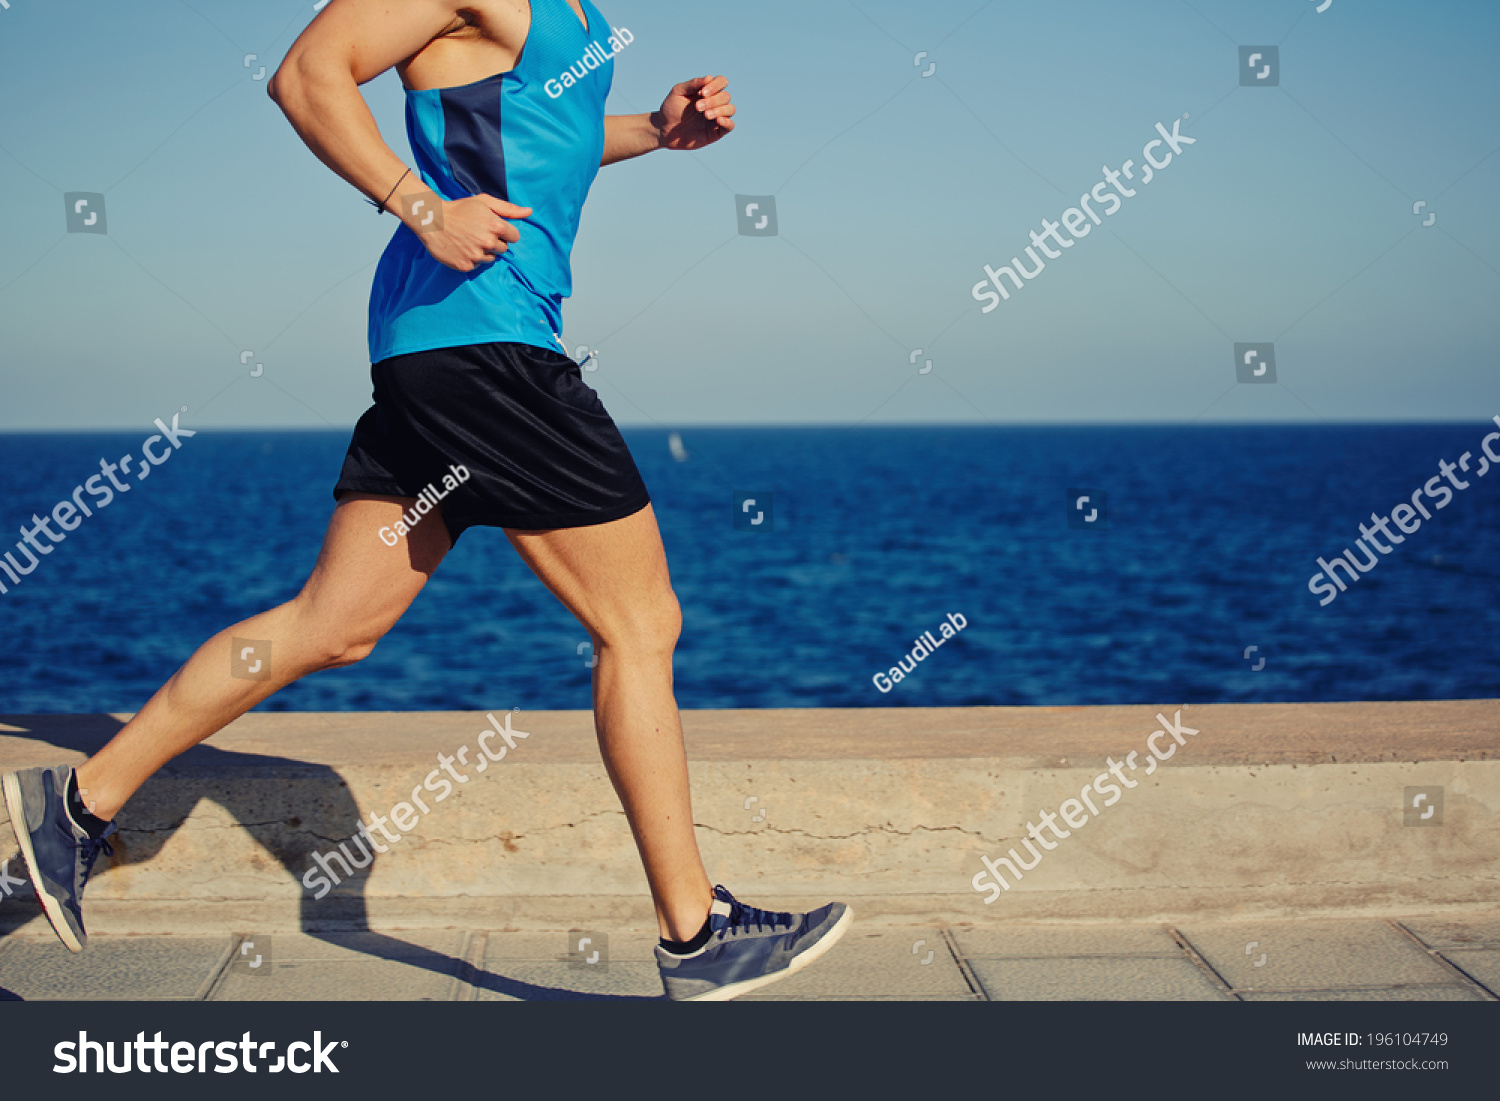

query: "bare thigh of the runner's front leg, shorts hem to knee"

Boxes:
[506, 506, 678, 644]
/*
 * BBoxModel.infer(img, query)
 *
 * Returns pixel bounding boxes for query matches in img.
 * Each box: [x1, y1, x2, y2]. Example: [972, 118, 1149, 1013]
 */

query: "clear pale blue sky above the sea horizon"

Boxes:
[0, 0, 1500, 429]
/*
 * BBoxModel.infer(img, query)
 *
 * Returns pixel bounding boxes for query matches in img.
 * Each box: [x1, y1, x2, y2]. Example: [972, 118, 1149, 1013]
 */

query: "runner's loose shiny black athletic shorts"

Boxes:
[333, 344, 651, 542]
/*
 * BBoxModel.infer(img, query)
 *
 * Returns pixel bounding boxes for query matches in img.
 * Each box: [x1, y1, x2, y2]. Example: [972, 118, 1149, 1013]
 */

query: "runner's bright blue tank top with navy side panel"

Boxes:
[369, 0, 632, 363]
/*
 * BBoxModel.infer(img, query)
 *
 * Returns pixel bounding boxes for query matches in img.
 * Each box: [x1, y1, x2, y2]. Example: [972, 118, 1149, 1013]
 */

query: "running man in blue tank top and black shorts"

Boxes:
[3, 0, 852, 1001]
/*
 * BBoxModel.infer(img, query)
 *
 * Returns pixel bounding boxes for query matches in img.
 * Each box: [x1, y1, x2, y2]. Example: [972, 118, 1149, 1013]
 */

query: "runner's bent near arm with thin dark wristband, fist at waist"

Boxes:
[267, 0, 531, 272]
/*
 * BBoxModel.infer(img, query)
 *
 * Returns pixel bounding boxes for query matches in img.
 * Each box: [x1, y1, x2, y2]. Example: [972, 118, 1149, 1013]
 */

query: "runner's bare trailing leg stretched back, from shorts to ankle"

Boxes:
[78, 494, 450, 819]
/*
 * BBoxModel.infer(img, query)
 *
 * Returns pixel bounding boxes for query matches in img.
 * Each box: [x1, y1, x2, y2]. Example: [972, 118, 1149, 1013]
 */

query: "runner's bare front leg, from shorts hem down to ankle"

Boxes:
[506, 506, 714, 941]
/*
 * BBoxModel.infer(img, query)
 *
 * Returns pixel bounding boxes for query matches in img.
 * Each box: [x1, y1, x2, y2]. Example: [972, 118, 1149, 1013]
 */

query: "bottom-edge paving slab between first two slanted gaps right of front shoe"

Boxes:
[969, 957, 1229, 1002]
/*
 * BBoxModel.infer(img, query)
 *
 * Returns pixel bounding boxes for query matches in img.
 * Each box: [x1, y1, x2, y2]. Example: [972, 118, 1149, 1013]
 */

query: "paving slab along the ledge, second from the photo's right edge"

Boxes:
[1178, 920, 1454, 990]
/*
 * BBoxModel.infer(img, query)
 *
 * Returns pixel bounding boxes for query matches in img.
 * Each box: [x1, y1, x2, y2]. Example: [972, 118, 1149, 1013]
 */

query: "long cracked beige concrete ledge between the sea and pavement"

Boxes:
[0, 701, 1500, 933]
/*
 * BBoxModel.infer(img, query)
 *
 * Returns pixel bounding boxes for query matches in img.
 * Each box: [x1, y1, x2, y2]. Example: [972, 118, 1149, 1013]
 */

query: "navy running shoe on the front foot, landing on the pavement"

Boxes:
[657, 887, 854, 1002]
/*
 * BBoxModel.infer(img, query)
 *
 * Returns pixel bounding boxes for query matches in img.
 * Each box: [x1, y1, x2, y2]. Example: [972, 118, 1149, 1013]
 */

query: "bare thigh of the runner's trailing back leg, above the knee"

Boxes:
[297, 494, 452, 641]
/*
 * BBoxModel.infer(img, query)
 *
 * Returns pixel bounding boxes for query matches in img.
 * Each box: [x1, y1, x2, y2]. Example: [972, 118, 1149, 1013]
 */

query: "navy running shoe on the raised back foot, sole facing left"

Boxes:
[0, 765, 114, 953]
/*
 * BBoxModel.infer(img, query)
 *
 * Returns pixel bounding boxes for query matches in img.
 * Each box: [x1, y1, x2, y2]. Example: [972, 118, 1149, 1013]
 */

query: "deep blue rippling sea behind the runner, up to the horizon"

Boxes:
[0, 420, 1500, 713]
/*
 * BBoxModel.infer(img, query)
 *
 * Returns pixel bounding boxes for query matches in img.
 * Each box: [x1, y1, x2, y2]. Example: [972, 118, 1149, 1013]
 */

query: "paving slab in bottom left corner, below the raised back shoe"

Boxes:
[0, 936, 230, 1002]
